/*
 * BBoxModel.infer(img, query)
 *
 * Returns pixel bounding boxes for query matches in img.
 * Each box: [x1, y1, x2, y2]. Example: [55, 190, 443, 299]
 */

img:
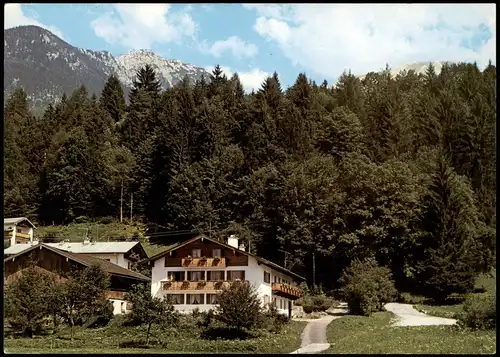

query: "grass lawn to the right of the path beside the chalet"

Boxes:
[323, 312, 496, 354]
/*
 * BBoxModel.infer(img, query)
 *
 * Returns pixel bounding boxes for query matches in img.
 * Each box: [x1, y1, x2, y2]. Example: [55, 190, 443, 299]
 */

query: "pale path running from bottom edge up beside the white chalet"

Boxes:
[292, 305, 347, 354]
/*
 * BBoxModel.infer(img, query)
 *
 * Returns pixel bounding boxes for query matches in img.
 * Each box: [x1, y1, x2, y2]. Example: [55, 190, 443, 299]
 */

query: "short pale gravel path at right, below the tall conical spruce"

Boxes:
[384, 302, 457, 326]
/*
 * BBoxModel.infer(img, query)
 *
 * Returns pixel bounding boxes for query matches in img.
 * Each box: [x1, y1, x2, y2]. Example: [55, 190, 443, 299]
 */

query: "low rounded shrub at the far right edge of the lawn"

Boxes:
[457, 295, 497, 329]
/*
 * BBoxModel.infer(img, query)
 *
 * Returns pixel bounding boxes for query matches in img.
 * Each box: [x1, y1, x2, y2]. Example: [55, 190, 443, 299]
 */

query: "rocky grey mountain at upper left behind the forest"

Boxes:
[4, 26, 208, 108]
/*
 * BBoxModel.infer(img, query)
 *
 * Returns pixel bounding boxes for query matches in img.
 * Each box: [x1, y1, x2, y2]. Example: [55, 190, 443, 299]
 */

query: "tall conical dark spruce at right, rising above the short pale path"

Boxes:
[417, 154, 480, 302]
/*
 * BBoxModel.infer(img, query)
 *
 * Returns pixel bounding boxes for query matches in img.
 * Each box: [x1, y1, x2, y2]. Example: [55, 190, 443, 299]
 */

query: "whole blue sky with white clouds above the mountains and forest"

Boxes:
[4, 4, 496, 90]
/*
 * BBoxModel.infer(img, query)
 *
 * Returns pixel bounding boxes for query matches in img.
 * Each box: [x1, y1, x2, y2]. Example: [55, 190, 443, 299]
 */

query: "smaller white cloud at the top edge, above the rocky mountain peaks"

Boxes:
[90, 4, 196, 49]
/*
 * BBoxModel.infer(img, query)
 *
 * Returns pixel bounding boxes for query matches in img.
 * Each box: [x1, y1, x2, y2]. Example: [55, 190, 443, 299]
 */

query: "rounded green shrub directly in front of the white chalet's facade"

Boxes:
[215, 281, 262, 329]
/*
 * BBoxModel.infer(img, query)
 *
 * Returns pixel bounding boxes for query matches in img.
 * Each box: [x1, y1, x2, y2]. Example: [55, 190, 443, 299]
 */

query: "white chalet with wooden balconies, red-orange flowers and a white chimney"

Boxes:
[148, 236, 305, 316]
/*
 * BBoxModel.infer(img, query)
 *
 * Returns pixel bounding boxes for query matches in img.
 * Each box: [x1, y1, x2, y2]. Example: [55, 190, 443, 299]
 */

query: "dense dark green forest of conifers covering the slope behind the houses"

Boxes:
[4, 63, 496, 287]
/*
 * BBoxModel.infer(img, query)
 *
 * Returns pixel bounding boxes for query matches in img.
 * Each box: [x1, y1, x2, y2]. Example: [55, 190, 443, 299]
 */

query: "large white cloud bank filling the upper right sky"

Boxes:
[243, 4, 496, 79]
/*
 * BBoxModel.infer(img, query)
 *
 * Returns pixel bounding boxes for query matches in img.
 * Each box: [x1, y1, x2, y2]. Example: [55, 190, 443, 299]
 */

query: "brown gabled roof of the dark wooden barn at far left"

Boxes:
[4, 243, 151, 282]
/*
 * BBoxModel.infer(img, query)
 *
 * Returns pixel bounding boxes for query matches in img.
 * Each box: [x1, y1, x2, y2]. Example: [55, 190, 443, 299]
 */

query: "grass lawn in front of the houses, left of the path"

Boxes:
[4, 321, 306, 354]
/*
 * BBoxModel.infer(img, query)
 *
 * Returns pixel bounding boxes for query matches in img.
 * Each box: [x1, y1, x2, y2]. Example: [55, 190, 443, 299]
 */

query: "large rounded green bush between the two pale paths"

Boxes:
[341, 258, 397, 316]
